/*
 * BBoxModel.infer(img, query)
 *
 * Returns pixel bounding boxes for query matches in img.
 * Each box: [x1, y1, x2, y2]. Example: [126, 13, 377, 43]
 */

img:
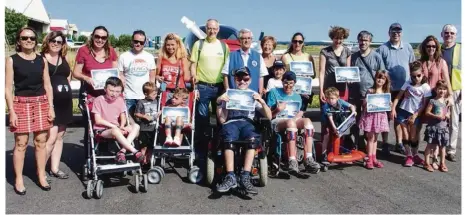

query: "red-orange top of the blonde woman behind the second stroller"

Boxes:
[160, 58, 186, 89]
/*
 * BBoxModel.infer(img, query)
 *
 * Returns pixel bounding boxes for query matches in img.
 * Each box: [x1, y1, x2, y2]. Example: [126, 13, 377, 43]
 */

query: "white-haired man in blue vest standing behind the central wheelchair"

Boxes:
[221, 28, 268, 94]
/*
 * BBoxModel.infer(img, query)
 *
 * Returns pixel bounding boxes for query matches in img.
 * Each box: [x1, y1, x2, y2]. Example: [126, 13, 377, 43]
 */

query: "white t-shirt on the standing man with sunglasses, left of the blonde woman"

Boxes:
[118, 51, 156, 99]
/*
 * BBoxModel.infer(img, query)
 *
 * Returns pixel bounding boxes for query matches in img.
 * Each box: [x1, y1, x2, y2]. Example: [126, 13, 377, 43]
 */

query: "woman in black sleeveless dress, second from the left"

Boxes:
[42, 31, 73, 179]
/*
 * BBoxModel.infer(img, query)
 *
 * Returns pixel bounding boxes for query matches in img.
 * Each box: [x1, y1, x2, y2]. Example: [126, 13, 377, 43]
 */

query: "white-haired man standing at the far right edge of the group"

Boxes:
[441, 24, 462, 162]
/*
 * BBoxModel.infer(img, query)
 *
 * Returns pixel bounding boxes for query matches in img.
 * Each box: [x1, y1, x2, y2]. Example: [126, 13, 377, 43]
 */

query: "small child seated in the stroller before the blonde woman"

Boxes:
[164, 88, 189, 147]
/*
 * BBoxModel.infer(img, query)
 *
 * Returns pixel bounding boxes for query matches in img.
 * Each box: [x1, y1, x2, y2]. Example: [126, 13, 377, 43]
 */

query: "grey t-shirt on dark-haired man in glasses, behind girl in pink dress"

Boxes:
[350, 50, 385, 96]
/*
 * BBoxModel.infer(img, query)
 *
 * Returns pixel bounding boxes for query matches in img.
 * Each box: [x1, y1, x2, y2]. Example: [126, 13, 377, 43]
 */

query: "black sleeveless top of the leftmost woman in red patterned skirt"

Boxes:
[11, 54, 45, 96]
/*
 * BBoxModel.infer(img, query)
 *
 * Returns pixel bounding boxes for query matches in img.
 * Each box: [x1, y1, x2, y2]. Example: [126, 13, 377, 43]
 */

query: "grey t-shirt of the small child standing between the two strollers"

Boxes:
[135, 99, 158, 131]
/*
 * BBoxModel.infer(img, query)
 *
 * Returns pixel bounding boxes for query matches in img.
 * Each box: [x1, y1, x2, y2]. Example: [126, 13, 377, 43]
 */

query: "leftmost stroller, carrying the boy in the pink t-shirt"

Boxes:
[82, 95, 148, 199]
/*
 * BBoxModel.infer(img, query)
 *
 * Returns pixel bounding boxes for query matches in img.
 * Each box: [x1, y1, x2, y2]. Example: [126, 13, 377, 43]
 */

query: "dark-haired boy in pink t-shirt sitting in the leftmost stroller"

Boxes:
[92, 77, 144, 164]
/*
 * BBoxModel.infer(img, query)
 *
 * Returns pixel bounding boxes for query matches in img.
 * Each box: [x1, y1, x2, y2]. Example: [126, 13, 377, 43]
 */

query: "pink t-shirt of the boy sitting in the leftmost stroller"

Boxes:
[92, 95, 126, 130]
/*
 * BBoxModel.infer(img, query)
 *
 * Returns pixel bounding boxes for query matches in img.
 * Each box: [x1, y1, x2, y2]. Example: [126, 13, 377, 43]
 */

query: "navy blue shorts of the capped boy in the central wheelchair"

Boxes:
[220, 120, 260, 142]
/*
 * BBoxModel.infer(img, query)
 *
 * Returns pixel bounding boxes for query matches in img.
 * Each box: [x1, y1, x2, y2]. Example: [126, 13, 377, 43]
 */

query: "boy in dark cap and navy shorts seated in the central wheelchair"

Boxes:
[216, 68, 271, 194]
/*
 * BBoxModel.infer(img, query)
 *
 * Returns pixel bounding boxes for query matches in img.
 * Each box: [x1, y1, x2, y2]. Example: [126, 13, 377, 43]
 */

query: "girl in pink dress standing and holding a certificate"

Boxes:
[359, 70, 391, 169]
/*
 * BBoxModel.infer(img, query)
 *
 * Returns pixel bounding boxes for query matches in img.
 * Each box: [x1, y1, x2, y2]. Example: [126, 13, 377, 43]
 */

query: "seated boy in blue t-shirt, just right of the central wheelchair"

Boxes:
[266, 71, 320, 173]
